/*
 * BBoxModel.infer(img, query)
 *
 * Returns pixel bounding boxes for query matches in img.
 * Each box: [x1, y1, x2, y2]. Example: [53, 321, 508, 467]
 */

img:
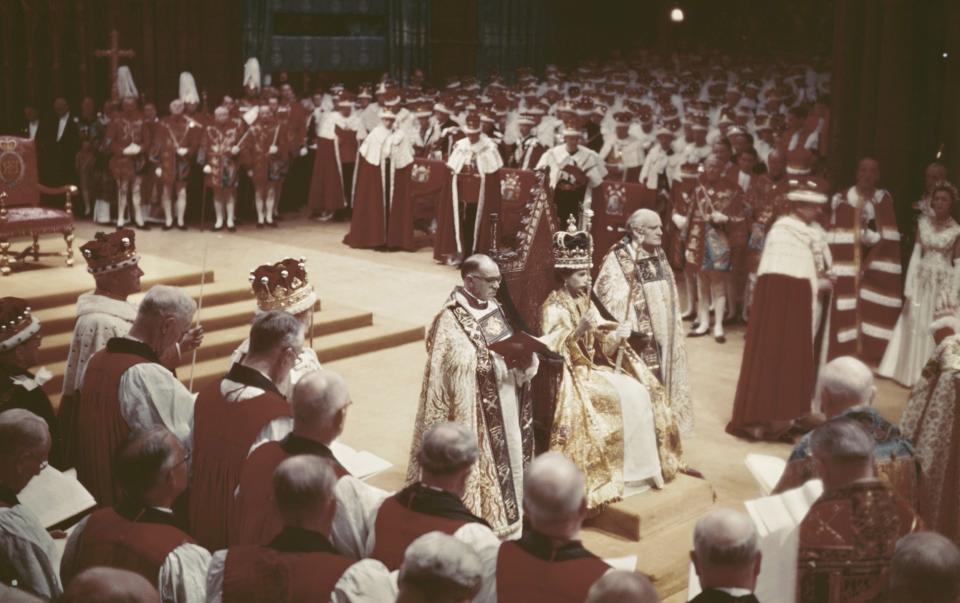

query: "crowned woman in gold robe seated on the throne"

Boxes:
[540, 219, 681, 509]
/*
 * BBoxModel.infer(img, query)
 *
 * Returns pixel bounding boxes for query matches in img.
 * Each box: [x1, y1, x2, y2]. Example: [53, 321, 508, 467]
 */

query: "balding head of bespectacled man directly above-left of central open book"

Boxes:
[292, 369, 350, 446]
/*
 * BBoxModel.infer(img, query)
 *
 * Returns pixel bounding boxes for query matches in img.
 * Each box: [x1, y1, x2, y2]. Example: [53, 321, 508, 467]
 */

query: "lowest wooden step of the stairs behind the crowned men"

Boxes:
[186, 317, 424, 391]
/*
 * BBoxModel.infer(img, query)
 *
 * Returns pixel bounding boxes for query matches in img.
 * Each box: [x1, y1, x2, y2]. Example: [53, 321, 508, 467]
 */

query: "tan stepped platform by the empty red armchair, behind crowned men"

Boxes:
[0, 255, 424, 406]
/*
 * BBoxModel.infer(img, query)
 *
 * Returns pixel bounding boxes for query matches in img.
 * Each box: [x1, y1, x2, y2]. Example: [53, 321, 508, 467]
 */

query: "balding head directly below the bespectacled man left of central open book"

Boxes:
[273, 454, 337, 527]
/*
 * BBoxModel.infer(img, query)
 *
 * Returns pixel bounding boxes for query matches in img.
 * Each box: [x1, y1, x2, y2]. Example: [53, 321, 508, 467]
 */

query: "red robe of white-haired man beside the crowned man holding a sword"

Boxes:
[74, 337, 160, 506]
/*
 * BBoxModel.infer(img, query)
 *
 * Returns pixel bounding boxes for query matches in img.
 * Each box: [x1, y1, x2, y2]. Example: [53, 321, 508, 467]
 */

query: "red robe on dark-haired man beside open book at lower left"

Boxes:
[75, 508, 193, 585]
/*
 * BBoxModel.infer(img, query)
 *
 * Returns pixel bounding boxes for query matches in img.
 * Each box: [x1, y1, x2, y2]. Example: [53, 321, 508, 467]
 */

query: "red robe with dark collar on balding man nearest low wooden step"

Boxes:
[497, 529, 610, 603]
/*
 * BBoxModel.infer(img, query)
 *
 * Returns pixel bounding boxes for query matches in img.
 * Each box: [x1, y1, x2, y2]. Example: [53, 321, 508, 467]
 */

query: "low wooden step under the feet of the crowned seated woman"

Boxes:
[586, 474, 716, 541]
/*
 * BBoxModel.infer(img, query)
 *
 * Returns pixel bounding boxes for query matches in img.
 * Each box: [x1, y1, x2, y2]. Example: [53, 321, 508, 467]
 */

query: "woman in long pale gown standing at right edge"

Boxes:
[877, 182, 960, 387]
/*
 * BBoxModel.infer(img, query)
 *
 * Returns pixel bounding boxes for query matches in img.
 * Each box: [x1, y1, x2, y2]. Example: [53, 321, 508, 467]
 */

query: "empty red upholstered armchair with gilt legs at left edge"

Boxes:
[0, 136, 77, 276]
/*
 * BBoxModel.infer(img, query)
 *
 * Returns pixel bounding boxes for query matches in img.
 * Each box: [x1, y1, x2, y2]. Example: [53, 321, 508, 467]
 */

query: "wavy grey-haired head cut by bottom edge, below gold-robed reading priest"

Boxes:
[398, 532, 483, 603]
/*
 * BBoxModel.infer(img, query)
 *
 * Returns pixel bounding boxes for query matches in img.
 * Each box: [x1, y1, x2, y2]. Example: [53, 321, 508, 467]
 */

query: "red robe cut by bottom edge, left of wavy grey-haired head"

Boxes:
[223, 528, 353, 603]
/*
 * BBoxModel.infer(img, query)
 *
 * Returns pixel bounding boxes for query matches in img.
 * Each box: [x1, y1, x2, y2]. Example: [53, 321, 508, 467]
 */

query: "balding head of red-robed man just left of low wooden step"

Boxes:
[523, 452, 586, 539]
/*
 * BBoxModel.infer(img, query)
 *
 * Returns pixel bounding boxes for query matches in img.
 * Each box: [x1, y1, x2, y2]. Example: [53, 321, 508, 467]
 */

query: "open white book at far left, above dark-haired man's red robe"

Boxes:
[17, 465, 97, 529]
